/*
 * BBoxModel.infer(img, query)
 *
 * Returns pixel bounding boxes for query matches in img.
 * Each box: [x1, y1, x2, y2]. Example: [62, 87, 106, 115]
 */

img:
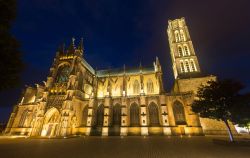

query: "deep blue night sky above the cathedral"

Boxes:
[0, 0, 250, 122]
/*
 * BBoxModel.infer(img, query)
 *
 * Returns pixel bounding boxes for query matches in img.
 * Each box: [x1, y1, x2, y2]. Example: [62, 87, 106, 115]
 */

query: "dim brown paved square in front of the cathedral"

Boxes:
[0, 136, 250, 158]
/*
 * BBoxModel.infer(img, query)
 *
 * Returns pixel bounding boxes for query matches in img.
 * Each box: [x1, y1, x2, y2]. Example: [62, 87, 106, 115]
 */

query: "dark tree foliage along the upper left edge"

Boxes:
[0, 0, 23, 91]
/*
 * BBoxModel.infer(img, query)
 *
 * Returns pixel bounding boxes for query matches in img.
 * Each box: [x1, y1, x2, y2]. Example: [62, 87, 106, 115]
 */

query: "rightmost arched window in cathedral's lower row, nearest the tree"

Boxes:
[173, 101, 186, 125]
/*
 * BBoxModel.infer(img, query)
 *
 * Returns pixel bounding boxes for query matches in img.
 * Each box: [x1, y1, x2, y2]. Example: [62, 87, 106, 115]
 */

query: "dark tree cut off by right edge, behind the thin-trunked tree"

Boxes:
[232, 93, 250, 134]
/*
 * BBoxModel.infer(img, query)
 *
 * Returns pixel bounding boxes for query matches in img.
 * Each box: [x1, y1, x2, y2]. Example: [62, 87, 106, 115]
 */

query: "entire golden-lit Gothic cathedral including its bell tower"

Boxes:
[5, 18, 236, 137]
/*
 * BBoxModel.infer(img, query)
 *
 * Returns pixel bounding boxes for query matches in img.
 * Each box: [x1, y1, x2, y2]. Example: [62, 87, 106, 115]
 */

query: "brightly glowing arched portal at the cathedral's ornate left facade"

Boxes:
[41, 108, 60, 137]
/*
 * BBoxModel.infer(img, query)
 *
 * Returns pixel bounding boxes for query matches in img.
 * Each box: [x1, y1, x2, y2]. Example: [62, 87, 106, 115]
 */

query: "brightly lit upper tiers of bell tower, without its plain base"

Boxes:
[167, 18, 200, 79]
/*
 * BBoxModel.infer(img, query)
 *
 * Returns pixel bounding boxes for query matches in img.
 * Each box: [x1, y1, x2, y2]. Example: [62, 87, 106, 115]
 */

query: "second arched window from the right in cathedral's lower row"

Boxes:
[148, 103, 160, 126]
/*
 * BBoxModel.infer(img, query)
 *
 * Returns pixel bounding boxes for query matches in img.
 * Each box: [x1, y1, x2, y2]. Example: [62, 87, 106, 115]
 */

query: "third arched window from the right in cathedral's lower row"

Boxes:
[130, 104, 140, 127]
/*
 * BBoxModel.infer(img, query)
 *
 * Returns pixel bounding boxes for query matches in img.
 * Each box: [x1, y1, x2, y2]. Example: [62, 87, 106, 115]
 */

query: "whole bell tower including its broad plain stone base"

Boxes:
[167, 18, 216, 93]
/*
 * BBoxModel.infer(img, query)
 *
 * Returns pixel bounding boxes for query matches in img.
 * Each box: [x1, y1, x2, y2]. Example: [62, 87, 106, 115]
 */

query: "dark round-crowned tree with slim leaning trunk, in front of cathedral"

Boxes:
[192, 79, 244, 141]
